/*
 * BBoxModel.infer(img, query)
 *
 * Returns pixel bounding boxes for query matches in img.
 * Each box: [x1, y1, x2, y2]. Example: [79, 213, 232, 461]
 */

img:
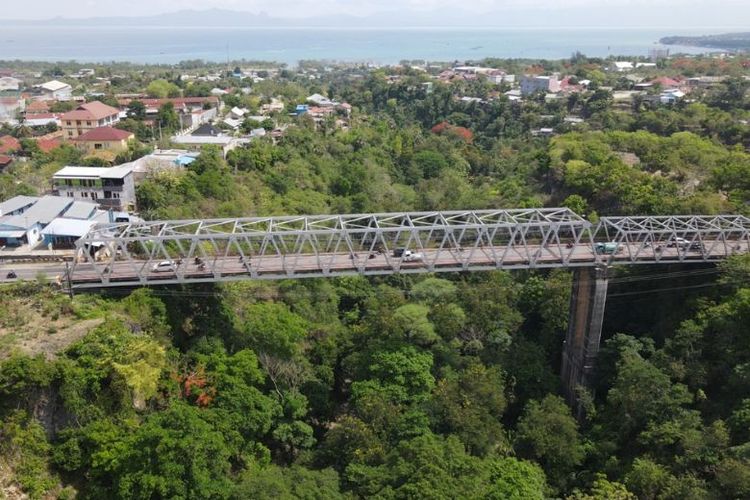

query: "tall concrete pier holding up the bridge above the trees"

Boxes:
[561, 266, 607, 420]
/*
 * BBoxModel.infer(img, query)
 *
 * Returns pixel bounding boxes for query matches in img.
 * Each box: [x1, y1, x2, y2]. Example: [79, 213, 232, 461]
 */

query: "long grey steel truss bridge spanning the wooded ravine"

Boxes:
[66, 208, 750, 289]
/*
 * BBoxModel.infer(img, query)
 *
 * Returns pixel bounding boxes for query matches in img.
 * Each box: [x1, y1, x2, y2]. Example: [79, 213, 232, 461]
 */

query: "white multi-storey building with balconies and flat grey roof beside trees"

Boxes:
[52, 163, 135, 212]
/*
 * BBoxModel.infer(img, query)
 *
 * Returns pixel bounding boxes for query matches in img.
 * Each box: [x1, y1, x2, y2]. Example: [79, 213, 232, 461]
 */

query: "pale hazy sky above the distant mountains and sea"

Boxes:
[0, 0, 750, 23]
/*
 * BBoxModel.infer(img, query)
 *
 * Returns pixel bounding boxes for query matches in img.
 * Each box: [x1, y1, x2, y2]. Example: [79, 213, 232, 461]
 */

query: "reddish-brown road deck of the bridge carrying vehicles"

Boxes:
[64, 240, 750, 288]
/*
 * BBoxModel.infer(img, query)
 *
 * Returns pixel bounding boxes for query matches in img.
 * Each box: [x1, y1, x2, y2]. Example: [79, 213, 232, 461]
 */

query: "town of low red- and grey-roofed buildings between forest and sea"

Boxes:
[0, 50, 750, 253]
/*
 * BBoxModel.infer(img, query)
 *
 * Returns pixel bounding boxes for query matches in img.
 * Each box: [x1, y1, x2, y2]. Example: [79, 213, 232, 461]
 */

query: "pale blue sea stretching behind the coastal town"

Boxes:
[0, 25, 721, 65]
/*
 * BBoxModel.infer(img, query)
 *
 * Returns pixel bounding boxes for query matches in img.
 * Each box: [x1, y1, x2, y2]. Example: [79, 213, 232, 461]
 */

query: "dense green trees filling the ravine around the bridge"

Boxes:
[0, 55, 750, 500]
